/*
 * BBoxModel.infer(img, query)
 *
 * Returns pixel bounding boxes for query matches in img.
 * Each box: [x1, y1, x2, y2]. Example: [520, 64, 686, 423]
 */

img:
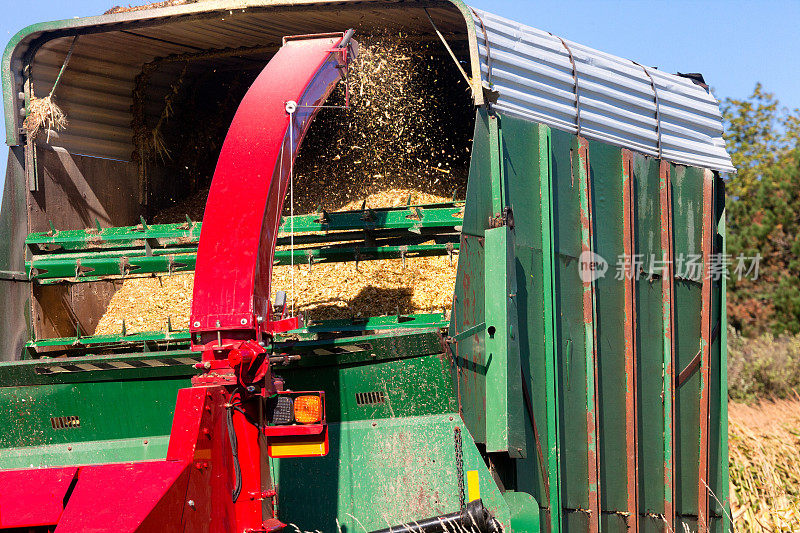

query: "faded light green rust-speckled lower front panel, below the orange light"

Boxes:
[273, 412, 522, 533]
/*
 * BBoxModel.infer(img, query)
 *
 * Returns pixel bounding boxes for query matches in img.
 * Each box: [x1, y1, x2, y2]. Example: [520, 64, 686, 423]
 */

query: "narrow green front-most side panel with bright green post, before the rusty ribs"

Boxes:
[502, 112, 561, 531]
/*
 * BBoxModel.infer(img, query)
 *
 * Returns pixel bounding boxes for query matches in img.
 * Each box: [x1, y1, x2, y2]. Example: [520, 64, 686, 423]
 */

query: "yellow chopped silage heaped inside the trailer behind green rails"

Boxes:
[95, 189, 456, 335]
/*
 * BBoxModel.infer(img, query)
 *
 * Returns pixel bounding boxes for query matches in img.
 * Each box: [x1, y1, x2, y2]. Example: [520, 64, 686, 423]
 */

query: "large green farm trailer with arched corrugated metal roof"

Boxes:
[0, 0, 732, 533]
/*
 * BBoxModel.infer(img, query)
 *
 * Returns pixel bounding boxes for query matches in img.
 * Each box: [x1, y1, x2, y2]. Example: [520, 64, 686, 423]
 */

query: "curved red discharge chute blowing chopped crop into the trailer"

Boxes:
[190, 34, 355, 344]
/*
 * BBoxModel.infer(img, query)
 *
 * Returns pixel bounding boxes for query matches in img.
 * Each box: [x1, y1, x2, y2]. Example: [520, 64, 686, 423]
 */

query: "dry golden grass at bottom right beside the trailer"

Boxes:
[728, 396, 800, 533]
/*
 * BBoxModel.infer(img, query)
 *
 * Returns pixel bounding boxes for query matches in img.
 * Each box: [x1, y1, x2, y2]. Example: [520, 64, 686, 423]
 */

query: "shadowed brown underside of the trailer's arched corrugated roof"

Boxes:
[4, 0, 478, 160]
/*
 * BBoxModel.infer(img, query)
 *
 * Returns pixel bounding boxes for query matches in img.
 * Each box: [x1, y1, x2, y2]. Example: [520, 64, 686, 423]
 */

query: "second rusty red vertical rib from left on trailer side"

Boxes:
[622, 150, 639, 531]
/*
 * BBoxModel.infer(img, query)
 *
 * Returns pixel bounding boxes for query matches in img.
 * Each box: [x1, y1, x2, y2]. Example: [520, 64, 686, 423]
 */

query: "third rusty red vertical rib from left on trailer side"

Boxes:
[659, 161, 676, 533]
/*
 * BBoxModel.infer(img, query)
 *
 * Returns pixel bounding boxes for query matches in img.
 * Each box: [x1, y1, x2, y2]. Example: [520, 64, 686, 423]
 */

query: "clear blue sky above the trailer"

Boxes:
[0, 0, 800, 176]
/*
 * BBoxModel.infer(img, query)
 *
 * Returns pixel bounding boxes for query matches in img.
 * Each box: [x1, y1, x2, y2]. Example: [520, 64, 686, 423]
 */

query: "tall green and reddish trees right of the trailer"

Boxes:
[722, 84, 800, 334]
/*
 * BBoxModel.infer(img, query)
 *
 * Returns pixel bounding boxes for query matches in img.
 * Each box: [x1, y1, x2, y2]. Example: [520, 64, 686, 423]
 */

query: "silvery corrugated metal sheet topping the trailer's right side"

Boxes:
[474, 10, 734, 172]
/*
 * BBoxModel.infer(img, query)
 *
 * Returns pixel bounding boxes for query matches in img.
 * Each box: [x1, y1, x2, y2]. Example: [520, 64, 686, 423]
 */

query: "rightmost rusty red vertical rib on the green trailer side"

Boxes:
[697, 170, 716, 533]
